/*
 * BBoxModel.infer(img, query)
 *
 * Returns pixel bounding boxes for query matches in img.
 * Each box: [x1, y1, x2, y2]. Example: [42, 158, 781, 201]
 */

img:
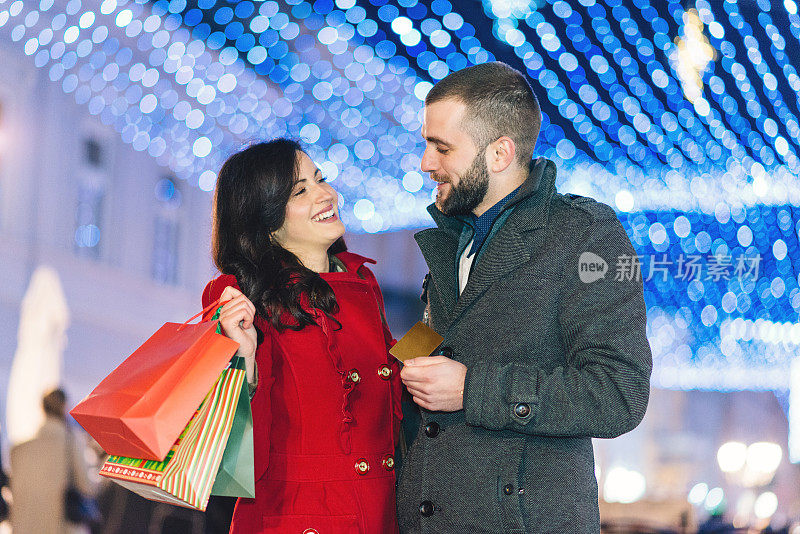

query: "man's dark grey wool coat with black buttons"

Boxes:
[397, 159, 652, 534]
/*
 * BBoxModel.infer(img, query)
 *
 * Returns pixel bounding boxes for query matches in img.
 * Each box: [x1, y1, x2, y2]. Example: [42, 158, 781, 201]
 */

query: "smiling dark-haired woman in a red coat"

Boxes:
[203, 139, 401, 534]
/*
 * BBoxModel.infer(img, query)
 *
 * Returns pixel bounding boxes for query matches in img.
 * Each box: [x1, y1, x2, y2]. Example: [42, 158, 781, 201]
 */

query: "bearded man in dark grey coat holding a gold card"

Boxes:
[398, 63, 652, 534]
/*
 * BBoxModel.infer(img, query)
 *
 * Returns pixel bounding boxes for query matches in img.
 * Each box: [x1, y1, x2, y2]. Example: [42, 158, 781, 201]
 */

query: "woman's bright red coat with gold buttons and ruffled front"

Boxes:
[203, 252, 402, 534]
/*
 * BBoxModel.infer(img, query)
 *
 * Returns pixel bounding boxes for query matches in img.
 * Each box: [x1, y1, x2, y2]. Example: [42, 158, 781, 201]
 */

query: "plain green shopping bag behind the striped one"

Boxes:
[211, 357, 256, 499]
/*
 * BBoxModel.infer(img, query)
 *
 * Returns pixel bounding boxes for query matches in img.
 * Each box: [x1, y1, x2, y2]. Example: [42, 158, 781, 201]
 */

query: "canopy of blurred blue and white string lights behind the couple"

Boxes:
[0, 0, 800, 392]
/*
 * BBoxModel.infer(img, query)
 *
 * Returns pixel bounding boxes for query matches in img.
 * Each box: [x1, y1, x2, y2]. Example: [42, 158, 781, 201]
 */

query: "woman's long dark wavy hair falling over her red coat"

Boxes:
[211, 138, 347, 330]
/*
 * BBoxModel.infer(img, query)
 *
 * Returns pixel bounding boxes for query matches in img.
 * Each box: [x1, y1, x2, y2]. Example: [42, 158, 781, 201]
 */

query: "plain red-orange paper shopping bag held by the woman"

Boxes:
[70, 301, 239, 461]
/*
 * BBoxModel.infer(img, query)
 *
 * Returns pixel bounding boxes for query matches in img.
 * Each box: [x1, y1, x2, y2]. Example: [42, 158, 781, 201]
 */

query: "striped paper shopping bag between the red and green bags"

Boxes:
[100, 364, 252, 511]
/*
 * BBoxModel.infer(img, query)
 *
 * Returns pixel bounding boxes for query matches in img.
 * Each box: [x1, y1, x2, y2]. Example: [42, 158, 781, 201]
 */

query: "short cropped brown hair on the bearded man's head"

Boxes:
[425, 61, 542, 168]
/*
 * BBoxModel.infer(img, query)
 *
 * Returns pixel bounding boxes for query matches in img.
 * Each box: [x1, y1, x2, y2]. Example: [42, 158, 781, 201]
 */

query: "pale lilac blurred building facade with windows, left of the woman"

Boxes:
[0, 40, 213, 410]
